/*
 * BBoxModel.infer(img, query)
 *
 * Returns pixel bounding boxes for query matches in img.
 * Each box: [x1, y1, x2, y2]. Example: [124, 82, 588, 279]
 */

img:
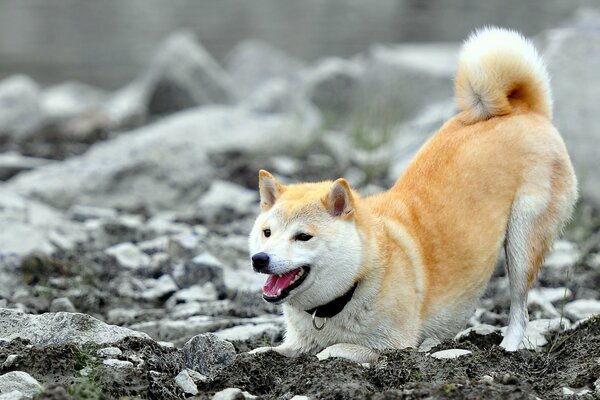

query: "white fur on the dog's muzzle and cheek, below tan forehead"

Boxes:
[249, 204, 362, 309]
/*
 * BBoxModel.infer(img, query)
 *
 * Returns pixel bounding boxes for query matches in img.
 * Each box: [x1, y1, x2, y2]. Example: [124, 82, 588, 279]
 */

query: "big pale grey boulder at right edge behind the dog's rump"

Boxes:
[541, 18, 600, 204]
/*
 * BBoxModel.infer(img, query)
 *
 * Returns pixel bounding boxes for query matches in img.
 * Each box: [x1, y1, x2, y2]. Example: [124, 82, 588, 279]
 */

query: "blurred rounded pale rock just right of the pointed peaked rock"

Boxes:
[225, 40, 304, 97]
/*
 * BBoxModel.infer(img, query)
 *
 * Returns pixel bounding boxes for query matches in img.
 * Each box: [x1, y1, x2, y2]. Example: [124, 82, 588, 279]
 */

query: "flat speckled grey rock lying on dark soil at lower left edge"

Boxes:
[0, 309, 148, 345]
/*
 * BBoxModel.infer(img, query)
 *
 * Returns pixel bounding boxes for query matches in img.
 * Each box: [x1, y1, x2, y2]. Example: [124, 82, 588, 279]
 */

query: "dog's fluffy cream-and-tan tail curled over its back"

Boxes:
[455, 27, 552, 123]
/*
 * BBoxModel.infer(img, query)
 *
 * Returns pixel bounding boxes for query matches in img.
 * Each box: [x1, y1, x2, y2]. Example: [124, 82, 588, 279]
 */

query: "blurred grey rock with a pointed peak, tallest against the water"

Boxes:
[144, 32, 236, 114]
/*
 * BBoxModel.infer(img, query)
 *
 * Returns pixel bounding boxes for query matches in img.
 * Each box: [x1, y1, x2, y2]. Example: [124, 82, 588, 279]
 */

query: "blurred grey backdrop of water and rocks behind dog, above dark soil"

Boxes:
[0, 0, 600, 394]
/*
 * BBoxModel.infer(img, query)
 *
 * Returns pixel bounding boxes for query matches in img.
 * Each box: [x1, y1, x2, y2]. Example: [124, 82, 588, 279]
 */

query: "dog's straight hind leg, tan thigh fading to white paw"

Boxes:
[500, 165, 577, 351]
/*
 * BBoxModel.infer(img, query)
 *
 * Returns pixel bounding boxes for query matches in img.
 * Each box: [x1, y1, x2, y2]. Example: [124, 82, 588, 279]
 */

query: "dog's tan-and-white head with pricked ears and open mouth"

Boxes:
[250, 171, 362, 309]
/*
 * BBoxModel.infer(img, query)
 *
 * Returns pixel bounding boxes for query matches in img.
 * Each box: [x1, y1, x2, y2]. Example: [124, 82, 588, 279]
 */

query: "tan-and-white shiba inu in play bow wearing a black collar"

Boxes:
[249, 28, 577, 362]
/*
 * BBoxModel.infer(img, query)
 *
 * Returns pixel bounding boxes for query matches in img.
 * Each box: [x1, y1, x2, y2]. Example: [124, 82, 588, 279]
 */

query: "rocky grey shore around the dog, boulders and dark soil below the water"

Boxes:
[0, 6, 600, 400]
